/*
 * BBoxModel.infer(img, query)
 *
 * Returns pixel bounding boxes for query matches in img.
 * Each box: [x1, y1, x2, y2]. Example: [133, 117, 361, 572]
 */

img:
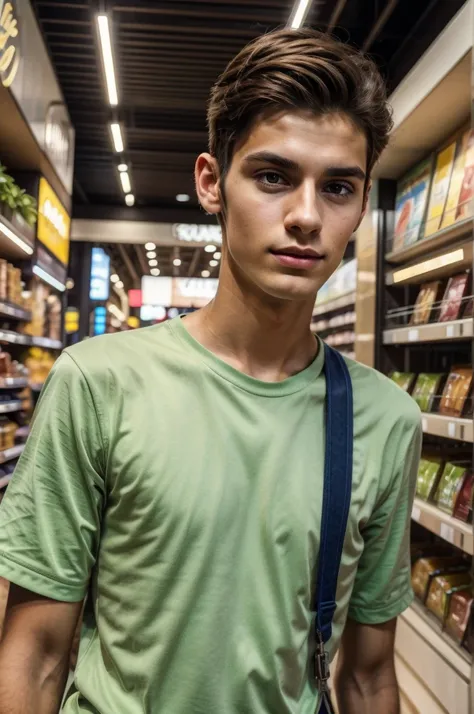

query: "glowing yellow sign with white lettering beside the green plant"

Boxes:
[38, 178, 71, 265]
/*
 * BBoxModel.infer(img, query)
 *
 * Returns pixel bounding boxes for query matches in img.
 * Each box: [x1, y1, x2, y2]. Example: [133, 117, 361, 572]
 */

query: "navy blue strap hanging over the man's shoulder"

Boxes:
[314, 344, 354, 708]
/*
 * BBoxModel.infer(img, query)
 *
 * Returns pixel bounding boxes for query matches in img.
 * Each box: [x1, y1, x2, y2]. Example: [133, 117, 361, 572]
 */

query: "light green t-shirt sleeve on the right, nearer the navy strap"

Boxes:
[349, 411, 422, 625]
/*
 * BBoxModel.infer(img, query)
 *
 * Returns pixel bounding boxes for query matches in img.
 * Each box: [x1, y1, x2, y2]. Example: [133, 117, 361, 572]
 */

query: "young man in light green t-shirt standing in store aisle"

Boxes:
[0, 30, 420, 714]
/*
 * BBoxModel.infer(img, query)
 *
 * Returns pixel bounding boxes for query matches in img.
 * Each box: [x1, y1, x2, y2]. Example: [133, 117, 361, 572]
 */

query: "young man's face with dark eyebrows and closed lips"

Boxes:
[196, 111, 367, 300]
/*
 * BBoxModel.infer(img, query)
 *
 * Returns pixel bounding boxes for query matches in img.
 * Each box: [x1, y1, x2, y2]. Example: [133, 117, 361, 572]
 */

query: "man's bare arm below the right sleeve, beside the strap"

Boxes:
[335, 620, 400, 714]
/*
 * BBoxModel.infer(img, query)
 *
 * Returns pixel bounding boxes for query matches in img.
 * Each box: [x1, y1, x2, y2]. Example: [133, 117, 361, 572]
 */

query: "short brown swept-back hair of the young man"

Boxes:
[207, 29, 392, 177]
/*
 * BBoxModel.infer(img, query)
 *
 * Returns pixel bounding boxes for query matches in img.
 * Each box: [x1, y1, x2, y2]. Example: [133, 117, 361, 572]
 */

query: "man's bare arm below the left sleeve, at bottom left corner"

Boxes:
[0, 584, 82, 714]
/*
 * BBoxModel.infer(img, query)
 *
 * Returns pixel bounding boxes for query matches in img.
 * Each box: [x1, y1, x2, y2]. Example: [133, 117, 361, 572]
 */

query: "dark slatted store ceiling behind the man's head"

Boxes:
[33, 0, 463, 221]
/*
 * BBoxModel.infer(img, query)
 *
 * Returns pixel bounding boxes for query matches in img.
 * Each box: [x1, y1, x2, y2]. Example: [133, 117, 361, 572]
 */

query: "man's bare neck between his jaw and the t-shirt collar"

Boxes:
[185, 268, 318, 382]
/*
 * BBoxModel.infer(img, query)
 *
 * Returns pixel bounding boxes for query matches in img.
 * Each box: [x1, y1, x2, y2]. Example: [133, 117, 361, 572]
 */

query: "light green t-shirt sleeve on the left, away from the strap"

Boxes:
[0, 353, 106, 602]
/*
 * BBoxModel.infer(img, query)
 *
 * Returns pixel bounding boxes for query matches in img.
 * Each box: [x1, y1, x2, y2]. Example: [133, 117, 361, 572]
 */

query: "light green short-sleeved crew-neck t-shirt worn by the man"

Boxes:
[0, 319, 420, 714]
